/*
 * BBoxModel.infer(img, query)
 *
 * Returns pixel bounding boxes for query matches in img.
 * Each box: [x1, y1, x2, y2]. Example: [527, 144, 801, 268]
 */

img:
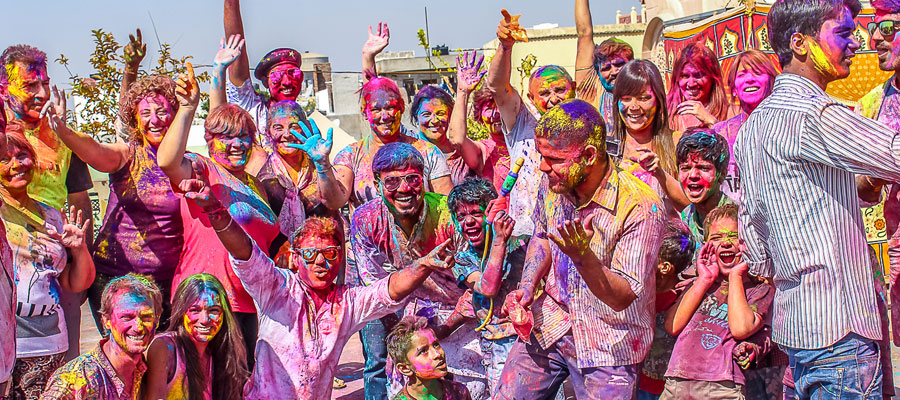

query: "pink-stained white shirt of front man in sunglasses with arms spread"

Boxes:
[231, 245, 402, 400]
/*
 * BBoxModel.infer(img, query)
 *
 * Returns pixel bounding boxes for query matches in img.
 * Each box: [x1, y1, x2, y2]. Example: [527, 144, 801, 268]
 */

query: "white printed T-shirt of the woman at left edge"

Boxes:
[0, 201, 69, 358]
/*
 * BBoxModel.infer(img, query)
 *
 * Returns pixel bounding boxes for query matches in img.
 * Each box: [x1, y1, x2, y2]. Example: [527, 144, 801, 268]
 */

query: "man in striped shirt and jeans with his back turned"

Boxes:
[735, 0, 900, 399]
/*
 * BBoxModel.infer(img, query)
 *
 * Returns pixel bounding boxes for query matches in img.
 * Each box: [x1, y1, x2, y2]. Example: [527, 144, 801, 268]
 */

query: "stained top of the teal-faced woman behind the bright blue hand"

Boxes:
[256, 151, 322, 237]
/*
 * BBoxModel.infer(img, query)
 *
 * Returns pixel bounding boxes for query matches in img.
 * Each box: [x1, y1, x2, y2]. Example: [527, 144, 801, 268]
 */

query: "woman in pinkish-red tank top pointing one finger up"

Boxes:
[158, 63, 280, 365]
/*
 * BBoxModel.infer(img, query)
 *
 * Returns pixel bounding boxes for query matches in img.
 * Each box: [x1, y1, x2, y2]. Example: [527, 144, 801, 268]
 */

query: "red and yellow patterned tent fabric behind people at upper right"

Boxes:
[660, 4, 891, 106]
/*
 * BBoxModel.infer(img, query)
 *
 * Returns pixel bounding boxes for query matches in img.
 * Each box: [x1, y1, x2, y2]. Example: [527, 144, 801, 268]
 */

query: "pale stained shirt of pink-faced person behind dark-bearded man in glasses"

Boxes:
[333, 125, 450, 210]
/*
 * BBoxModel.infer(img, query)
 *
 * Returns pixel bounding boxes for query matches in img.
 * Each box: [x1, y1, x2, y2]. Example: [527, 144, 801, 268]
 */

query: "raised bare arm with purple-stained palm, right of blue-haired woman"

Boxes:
[447, 51, 487, 176]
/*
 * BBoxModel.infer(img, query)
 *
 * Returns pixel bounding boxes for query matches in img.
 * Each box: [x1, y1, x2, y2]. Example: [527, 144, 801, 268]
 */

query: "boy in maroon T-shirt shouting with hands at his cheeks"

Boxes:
[661, 204, 775, 399]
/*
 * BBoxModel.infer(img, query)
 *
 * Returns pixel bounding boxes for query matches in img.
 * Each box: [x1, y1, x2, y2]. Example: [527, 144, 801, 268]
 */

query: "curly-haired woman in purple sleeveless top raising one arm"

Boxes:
[47, 75, 184, 332]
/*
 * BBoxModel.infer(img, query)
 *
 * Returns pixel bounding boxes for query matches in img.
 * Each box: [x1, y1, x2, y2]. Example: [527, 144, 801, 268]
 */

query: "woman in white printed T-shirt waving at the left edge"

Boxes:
[0, 129, 94, 399]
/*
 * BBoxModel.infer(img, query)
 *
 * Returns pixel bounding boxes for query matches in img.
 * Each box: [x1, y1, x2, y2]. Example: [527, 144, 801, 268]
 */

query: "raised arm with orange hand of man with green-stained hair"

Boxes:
[487, 10, 522, 129]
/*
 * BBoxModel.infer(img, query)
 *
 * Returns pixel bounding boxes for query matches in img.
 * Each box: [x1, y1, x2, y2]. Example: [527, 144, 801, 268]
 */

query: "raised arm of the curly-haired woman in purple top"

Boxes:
[44, 85, 128, 173]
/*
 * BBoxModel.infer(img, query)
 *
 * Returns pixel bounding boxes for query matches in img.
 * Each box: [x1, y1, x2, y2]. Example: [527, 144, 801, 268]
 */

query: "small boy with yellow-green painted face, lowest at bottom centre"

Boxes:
[386, 316, 471, 400]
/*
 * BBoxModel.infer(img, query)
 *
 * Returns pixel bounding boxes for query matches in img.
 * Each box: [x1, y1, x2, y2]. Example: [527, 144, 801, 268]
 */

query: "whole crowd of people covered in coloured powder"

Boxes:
[0, 0, 900, 400]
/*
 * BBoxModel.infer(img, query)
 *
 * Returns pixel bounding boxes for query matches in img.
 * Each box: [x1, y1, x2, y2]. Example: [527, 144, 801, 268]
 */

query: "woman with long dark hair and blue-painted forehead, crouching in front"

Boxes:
[145, 274, 250, 400]
